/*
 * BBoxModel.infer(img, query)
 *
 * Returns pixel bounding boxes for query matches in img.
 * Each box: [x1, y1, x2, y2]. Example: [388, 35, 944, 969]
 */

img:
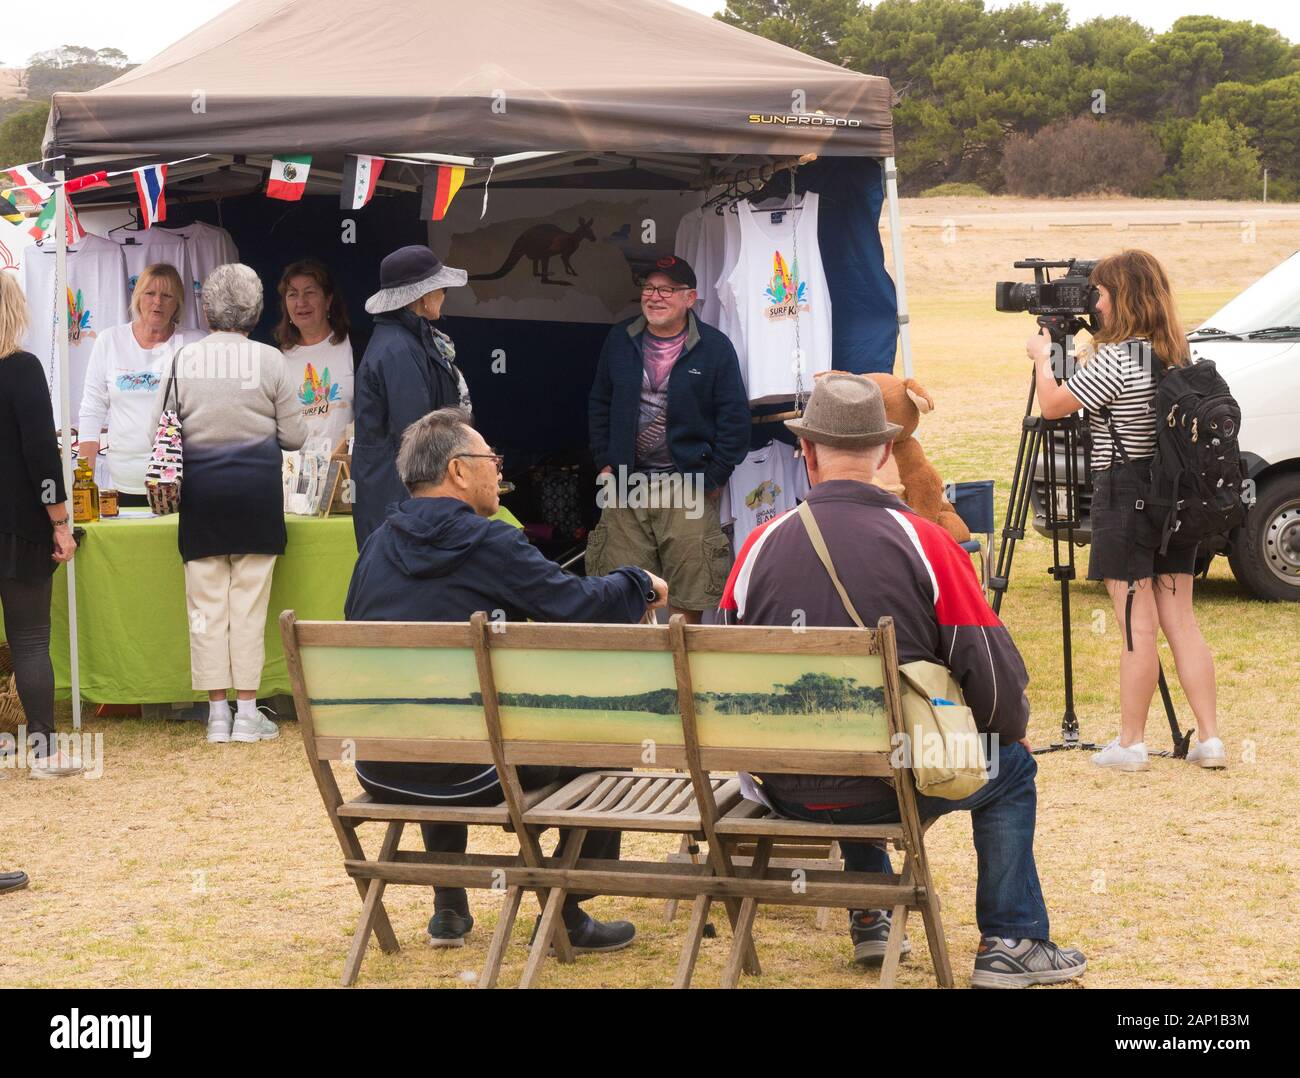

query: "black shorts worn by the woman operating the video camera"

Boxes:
[1088, 458, 1196, 580]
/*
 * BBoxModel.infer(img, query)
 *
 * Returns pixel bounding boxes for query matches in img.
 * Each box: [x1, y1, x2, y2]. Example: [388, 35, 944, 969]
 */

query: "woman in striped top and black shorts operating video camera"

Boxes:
[1027, 251, 1226, 771]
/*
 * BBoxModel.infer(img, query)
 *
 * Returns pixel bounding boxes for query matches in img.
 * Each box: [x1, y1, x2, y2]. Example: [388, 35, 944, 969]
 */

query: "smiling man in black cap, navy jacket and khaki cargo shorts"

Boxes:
[586, 255, 750, 622]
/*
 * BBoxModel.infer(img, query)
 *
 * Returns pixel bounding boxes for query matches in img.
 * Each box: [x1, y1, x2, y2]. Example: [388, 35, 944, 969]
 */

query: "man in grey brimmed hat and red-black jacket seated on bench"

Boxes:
[722, 372, 1087, 987]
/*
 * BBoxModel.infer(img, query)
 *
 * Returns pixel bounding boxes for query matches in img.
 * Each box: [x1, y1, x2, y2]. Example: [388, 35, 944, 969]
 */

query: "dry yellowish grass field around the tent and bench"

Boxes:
[0, 199, 1300, 987]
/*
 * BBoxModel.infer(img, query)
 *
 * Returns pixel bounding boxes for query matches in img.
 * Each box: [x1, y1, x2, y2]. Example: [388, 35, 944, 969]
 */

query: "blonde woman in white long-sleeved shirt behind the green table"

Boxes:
[77, 263, 195, 506]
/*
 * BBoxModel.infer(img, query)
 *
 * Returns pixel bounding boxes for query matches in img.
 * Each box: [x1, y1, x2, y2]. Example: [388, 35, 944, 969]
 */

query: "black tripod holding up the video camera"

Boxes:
[988, 316, 1192, 758]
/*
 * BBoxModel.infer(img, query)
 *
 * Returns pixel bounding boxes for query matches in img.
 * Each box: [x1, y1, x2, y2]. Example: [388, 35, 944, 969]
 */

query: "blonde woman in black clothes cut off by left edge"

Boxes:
[0, 270, 82, 779]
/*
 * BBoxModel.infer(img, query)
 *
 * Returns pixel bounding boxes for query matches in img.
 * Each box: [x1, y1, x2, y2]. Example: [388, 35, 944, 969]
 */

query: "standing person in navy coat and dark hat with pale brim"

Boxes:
[352, 243, 469, 550]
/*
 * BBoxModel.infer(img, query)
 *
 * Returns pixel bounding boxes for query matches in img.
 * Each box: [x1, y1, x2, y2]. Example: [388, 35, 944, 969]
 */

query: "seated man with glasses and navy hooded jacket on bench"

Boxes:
[345, 408, 668, 951]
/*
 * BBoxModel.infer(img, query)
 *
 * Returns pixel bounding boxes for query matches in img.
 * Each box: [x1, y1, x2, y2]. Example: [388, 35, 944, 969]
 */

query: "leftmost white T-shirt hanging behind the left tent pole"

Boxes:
[18, 234, 129, 424]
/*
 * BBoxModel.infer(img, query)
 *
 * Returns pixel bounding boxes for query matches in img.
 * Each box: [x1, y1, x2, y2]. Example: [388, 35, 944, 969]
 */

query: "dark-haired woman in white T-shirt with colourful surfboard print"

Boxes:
[276, 259, 352, 453]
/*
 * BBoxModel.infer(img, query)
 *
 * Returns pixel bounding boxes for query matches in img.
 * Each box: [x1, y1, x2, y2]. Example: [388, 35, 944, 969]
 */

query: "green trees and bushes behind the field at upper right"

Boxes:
[718, 0, 1300, 200]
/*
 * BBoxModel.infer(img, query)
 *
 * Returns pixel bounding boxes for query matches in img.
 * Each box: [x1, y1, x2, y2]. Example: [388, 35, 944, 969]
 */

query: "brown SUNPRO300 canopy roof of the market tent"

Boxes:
[47, 0, 893, 159]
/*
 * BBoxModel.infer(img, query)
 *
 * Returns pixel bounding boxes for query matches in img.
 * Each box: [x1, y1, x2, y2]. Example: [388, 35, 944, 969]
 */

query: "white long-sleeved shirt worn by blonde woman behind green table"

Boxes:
[77, 322, 199, 494]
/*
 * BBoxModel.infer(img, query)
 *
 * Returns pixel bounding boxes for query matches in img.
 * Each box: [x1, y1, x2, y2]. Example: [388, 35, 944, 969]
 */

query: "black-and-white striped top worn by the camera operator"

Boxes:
[1065, 339, 1160, 469]
